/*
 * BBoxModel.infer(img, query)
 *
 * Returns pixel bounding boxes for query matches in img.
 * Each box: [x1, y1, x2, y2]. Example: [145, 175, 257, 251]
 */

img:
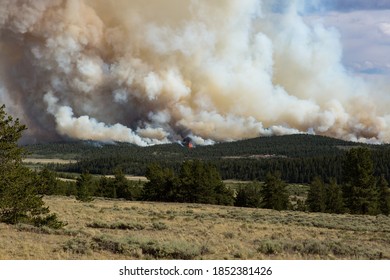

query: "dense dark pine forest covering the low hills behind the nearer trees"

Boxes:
[26, 134, 390, 183]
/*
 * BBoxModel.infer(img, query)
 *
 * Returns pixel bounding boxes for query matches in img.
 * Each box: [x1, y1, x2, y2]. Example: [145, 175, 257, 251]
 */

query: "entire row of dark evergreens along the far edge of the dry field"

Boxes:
[35, 145, 390, 215]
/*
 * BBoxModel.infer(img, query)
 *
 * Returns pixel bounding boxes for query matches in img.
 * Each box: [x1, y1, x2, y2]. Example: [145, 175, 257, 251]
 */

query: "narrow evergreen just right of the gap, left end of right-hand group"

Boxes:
[306, 177, 326, 212]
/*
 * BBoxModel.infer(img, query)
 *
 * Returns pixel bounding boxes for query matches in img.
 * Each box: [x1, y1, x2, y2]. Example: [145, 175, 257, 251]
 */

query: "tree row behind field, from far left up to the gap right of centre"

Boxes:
[38, 160, 291, 210]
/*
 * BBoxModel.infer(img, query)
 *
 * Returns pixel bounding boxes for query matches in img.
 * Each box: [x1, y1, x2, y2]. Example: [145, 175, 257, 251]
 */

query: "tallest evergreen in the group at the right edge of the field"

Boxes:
[343, 148, 378, 215]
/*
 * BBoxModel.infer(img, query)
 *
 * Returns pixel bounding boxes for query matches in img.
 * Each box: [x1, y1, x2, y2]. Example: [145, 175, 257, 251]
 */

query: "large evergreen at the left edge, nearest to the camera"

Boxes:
[0, 105, 64, 228]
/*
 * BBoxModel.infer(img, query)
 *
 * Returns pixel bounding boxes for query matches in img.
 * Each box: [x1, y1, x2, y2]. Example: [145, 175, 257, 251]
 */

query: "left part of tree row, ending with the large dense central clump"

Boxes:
[38, 161, 234, 205]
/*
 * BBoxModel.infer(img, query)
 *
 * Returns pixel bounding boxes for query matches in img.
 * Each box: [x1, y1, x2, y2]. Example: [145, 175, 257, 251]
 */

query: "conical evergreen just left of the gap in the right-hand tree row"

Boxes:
[261, 171, 289, 210]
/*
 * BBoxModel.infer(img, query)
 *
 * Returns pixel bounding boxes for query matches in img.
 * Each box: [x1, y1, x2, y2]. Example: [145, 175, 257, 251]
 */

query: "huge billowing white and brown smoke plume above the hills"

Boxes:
[0, 0, 390, 146]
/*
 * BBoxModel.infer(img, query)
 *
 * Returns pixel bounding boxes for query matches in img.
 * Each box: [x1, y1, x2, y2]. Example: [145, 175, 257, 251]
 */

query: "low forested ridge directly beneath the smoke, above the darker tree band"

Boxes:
[25, 134, 362, 159]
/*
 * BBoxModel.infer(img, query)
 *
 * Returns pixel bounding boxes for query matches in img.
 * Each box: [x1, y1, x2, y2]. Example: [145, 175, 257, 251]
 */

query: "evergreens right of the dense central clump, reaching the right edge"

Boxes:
[236, 147, 390, 215]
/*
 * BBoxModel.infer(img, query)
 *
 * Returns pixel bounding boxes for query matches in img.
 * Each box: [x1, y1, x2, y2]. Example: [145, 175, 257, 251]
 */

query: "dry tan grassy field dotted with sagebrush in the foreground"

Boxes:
[0, 197, 390, 260]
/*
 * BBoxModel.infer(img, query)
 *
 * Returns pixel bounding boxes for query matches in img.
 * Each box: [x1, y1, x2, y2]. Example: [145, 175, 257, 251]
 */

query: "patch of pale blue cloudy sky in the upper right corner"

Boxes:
[304, 0, 390, 77]
